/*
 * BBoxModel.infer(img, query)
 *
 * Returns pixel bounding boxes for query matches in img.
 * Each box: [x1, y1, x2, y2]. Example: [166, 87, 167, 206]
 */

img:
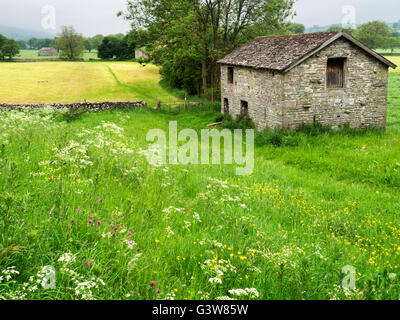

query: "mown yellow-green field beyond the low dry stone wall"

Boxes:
[0, 61, 180, 105]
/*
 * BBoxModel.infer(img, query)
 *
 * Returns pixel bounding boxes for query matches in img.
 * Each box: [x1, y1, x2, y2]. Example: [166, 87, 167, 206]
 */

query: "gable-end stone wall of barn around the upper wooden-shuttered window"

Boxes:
[282, 38, 388, 129]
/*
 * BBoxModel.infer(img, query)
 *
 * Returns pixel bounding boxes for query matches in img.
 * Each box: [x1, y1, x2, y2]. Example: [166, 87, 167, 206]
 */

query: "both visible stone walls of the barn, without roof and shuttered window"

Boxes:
[221, 38, 388, 129]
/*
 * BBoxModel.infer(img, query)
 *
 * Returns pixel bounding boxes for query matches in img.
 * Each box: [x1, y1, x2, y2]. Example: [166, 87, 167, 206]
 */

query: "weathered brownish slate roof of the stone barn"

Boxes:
[218, 31, 396, 72]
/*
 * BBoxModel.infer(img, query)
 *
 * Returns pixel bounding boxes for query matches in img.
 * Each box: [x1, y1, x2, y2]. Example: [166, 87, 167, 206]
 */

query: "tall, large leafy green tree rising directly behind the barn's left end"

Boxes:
[120, 0, 294, 95]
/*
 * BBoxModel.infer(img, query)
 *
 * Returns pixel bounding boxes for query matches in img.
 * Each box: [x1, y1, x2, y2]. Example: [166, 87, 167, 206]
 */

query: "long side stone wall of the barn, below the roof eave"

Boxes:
[221, 65, 283, 129]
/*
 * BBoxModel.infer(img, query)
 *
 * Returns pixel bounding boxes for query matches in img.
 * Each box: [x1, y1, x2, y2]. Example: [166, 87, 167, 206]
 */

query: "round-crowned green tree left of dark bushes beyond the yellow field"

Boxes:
[55, 26, 85, 60]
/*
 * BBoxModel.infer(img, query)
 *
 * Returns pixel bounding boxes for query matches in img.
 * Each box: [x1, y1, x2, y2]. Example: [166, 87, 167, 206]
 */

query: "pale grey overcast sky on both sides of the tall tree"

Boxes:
[0, 0, 400, 36]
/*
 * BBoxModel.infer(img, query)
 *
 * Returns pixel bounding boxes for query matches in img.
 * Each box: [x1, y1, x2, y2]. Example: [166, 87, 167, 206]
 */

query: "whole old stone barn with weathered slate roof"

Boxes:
[218, 31, 396, 130]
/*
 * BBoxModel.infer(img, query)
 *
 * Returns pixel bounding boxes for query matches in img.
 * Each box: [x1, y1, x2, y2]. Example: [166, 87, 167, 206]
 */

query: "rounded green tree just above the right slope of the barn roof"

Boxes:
[354, 20, 393, 49]
